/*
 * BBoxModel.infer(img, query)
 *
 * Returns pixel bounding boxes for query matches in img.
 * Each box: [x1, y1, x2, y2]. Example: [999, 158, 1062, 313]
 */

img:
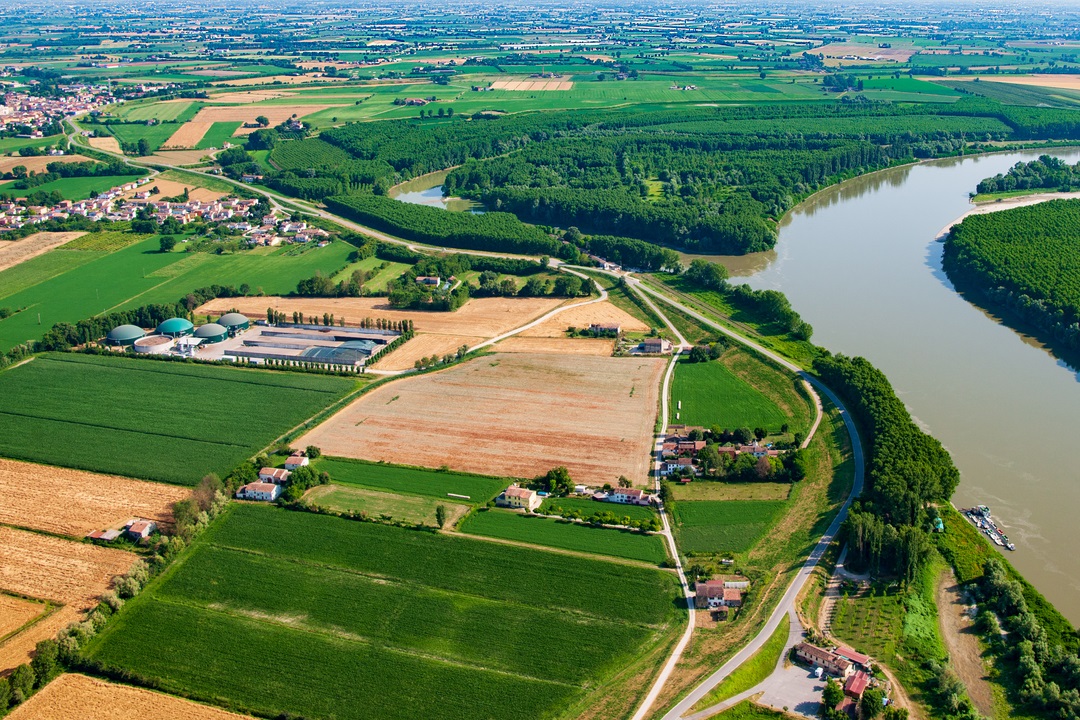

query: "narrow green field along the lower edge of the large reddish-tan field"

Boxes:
[314, 458, 511, 504]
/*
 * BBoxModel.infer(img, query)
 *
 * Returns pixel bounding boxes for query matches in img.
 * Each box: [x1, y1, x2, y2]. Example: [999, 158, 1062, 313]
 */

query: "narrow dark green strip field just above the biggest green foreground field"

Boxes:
[459, 510, 667, 565]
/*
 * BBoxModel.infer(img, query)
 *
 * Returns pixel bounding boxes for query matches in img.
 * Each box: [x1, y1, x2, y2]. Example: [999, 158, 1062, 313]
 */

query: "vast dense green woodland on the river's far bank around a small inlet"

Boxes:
[259, 98, 1080, 257]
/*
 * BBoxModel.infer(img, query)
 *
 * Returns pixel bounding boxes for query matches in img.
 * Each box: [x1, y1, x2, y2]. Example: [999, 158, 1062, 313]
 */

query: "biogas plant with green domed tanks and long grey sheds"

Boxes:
[104, 312, 401, 372]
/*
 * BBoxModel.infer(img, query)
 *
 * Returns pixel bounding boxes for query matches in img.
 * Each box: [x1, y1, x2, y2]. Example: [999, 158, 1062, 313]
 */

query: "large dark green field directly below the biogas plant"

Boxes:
[0, 353, 356, 485]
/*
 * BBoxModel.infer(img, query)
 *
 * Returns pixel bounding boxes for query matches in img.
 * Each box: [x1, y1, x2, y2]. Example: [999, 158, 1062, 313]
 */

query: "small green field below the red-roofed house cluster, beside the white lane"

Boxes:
[674, 500, 786, 553]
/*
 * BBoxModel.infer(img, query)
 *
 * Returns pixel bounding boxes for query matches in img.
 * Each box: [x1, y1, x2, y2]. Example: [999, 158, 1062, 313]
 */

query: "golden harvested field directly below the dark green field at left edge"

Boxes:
[0, 460, 191, 538]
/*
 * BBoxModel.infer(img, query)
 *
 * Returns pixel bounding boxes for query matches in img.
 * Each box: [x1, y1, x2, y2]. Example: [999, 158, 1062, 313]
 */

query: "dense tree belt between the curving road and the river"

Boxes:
[813, 355, 960, 581]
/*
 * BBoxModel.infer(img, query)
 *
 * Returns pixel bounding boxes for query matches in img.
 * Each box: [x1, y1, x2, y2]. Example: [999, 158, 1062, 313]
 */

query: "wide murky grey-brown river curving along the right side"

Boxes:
[724, 150, 1080, 624]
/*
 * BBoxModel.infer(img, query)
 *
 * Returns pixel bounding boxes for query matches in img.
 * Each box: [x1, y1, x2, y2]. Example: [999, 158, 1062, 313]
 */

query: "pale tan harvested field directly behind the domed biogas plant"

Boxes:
[195, 297, 563, 343]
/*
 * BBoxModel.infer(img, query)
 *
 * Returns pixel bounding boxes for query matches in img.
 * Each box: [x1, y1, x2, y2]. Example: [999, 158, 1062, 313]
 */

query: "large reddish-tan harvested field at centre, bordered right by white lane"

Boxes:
[296, 354, 664, 484]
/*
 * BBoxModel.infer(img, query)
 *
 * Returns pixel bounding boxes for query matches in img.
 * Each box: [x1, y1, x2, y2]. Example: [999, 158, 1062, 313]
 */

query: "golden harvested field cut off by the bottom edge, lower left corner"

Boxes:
[8, 674, 254, 720]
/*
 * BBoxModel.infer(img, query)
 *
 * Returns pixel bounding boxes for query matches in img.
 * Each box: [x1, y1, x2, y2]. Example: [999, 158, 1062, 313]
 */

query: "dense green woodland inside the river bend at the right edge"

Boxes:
[943, 199, 1080, 358]
